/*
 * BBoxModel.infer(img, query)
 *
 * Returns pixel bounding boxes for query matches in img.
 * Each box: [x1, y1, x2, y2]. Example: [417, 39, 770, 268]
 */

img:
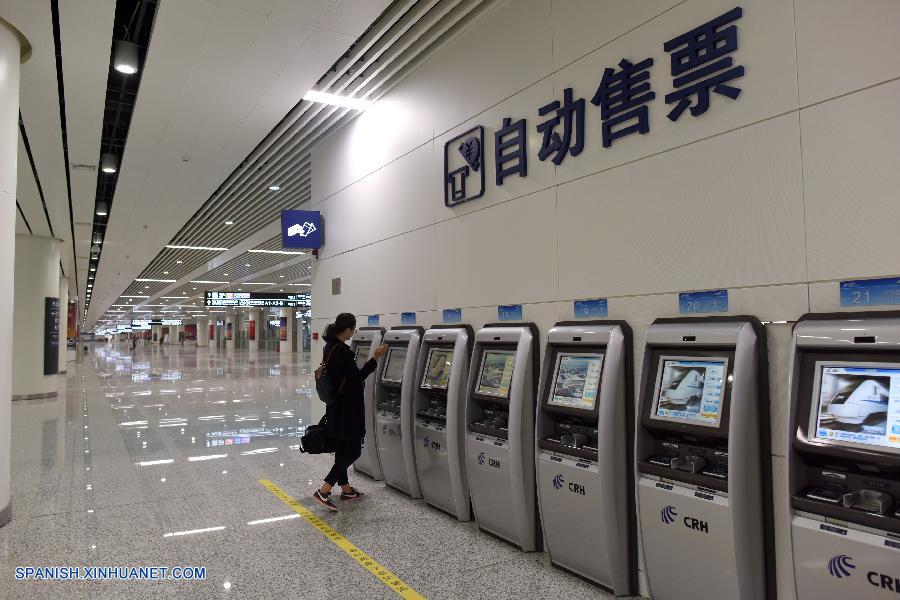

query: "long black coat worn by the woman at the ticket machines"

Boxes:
[323, 338, 378, 440]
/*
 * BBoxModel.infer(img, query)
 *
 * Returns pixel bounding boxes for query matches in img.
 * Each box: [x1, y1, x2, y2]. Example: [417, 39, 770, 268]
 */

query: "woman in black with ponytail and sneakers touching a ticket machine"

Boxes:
[313, 313, 388, 511]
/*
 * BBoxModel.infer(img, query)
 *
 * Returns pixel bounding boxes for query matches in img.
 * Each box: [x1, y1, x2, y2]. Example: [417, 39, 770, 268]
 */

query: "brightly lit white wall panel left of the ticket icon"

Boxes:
[317, 144, 440, 257]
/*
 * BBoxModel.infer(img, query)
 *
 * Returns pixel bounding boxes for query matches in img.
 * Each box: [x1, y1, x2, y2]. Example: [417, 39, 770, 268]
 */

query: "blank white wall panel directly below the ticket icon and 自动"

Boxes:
[434, 190, 557, 307]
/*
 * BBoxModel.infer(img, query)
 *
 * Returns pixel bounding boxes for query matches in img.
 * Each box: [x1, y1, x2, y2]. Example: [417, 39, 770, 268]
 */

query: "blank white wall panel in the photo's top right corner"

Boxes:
[794, 0, 900, 106]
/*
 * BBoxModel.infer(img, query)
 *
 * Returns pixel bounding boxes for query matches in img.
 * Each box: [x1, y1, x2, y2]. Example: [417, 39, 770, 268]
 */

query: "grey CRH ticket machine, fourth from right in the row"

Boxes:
[466, 323, 541, 552]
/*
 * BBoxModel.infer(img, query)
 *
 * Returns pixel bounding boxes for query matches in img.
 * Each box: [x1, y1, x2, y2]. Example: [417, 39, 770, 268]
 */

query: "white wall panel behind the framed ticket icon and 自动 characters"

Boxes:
[429, 79, 556, 221]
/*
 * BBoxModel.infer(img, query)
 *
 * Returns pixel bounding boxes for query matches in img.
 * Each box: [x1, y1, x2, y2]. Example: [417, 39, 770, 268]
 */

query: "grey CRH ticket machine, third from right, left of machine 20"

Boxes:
[537, 321, 637, 596]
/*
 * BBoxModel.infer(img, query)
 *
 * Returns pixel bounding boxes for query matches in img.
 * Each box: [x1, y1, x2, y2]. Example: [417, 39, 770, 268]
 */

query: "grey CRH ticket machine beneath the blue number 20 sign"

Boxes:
[635, 317, 775, 600]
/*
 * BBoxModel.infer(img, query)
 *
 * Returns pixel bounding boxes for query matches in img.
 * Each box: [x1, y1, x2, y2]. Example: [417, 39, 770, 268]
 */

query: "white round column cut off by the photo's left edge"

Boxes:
[0, 18, 34, 525]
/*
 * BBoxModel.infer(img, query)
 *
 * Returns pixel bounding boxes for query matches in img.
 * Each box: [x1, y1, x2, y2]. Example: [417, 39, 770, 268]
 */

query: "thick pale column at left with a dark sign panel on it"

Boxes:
[12, 235, 59, 400]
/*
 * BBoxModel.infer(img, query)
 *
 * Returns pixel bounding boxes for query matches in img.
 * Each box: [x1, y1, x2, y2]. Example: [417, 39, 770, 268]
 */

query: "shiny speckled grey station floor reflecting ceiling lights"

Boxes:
[0, 344, 620, 600]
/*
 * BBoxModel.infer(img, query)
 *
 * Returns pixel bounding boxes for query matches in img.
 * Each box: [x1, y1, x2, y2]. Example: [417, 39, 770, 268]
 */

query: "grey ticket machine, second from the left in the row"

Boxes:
[375, 326, 422, 498]
